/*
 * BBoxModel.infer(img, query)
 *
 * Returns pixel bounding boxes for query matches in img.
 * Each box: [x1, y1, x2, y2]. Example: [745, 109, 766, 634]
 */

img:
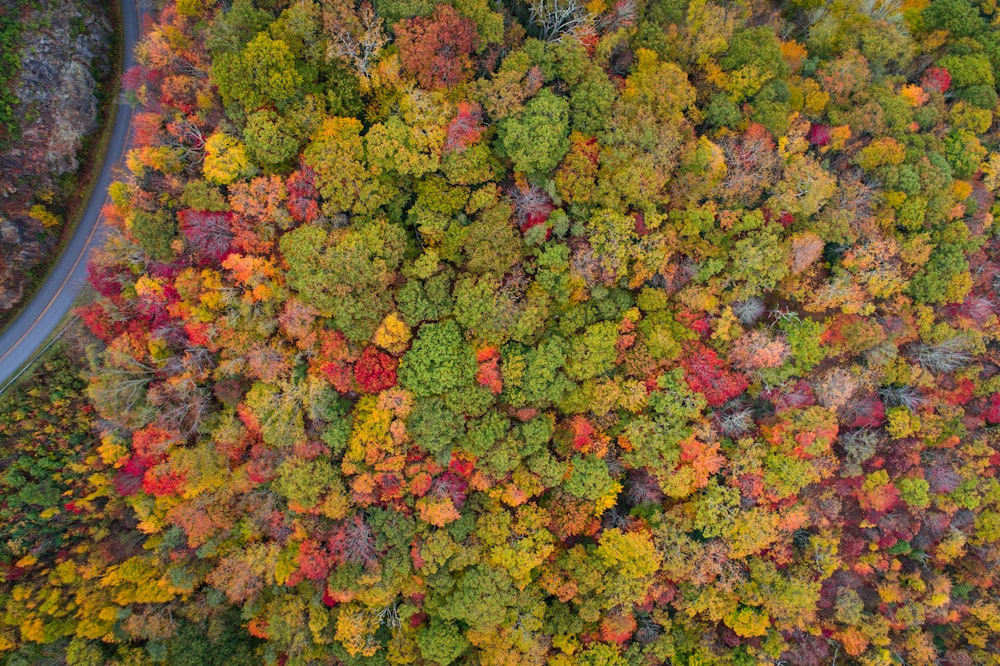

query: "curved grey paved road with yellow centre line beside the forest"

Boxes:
[0, 0, 139, 392]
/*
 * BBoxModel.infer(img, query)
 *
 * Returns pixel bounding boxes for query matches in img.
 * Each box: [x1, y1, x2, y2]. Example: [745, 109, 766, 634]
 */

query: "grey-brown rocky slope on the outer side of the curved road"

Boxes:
[0, 0, 113, 320]
